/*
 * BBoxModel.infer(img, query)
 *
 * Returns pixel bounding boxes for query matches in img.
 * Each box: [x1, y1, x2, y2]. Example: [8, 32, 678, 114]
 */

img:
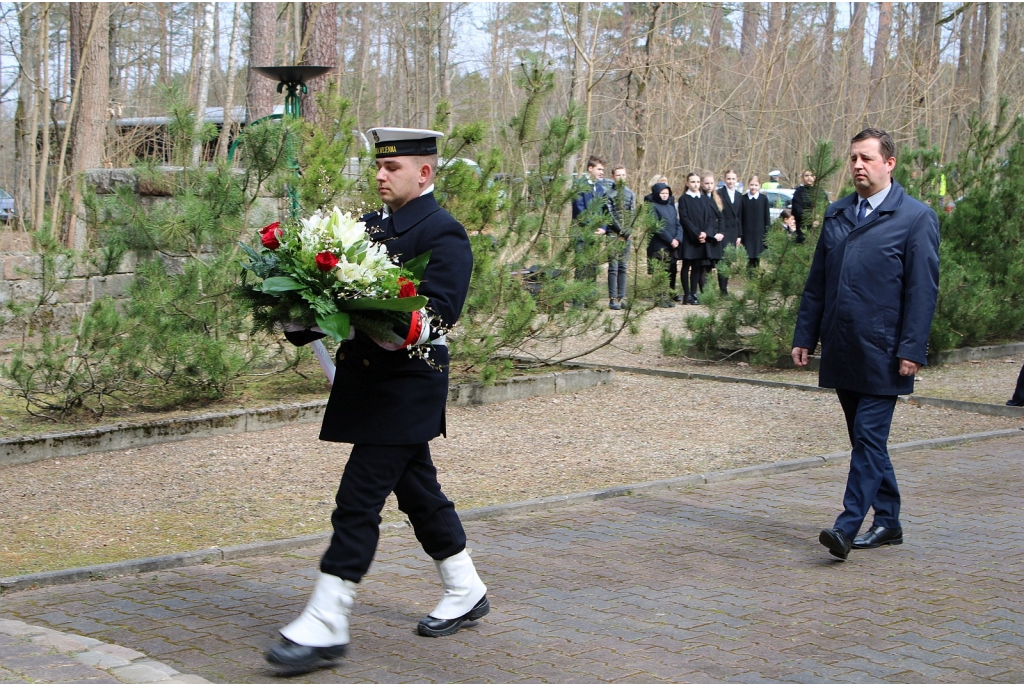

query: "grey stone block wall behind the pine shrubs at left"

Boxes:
[0, 168, 286, 338]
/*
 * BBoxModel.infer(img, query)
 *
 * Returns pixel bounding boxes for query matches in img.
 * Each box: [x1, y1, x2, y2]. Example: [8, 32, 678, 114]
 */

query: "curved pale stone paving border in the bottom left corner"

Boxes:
[0, 618, 210, 683]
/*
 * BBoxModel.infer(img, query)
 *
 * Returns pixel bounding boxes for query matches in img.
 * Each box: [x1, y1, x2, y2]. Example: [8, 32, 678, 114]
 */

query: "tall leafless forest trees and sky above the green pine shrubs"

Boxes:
[0, 2, 1024, 217]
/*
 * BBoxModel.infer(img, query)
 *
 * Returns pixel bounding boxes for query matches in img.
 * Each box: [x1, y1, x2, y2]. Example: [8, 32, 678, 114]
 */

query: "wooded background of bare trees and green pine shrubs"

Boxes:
[0, 2, 1024, 427]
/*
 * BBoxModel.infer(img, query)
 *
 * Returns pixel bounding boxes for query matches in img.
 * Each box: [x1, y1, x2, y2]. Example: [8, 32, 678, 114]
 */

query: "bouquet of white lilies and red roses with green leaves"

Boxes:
[238, 202, 430, 347]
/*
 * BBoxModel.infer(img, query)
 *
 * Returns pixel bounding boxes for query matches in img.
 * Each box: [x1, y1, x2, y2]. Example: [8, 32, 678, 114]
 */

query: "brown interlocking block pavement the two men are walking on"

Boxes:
[0, 437, 1024, 683]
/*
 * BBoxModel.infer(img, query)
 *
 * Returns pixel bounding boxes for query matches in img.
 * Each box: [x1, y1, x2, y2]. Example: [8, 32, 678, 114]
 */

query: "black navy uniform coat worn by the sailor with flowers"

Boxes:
[319, 194, 473, 444]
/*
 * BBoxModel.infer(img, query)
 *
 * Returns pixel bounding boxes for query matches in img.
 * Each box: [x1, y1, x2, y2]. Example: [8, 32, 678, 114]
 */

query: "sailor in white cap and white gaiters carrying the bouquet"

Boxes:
[266, 128, 489, 671]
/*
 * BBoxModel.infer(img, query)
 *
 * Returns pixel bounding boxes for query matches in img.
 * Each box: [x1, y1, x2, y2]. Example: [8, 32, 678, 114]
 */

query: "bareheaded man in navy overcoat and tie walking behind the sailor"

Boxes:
[793, 128, 939, 559]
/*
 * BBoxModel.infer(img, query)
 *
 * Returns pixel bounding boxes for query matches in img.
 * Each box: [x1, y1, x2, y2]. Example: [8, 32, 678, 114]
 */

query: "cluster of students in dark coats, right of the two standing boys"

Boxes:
[644, 169, 771, 307]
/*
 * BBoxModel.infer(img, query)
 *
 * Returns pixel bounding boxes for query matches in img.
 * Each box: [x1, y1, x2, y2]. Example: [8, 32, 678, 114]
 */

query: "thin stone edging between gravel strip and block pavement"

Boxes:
[0, 428, 1024, 596]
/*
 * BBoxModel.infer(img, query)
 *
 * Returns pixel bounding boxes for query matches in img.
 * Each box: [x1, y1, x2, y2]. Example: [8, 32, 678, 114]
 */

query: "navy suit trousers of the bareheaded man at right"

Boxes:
[835, 389, 900, 540]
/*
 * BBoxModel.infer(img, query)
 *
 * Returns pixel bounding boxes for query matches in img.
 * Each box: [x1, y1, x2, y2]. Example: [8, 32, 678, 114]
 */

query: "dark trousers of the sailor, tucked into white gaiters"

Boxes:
[321, 442, 466, 583]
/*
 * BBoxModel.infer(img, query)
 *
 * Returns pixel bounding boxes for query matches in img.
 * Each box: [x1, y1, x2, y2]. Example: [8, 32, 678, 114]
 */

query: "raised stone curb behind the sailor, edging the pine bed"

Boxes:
[0, 367, 613, 466]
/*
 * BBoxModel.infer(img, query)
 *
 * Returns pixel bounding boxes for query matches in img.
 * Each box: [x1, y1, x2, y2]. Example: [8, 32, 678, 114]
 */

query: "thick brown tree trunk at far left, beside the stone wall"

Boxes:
[62, 2, 111, 250]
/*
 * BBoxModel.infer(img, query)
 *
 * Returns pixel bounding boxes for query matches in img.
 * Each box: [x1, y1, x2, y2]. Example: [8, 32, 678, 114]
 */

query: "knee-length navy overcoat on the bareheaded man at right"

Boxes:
[793, 181, 939, 395]
